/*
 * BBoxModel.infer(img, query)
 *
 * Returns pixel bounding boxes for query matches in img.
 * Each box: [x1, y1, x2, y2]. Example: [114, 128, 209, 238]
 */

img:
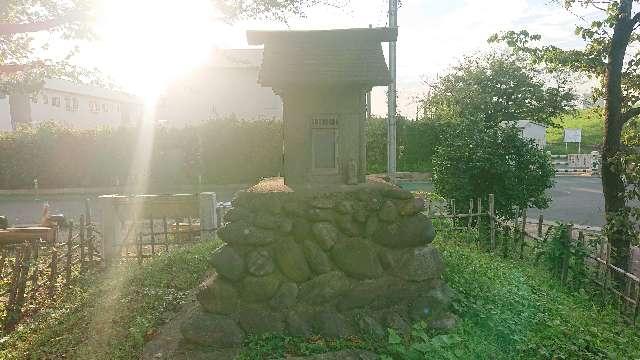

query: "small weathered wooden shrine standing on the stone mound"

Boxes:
[247, 28, 397, 186]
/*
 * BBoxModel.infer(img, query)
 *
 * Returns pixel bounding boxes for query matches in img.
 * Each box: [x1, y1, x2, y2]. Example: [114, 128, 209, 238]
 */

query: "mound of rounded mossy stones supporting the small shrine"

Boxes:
[181, 183, 455, 349]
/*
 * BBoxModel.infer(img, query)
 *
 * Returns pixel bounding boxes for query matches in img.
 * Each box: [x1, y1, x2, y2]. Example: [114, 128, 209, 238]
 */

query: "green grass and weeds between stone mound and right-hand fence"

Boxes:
[431, 233, 640, 359]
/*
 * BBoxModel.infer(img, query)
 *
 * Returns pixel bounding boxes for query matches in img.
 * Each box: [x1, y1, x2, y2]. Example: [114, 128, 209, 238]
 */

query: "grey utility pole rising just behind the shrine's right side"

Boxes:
[387, 0, 398, 183]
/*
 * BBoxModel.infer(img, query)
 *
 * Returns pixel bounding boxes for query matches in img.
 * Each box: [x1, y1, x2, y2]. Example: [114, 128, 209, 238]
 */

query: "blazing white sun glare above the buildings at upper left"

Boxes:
[96, 0, 221, 103]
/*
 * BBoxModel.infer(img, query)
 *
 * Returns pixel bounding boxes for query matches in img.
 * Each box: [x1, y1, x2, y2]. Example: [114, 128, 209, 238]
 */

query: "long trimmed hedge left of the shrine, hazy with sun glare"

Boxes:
[0, 119, 282, 189]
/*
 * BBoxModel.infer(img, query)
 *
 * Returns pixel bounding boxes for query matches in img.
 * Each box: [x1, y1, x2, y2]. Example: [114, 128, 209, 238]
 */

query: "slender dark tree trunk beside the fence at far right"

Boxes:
[602, 0, 633, 282]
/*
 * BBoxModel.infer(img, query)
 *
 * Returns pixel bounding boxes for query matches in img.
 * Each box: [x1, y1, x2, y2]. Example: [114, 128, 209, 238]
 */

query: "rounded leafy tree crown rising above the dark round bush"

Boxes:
[422, 53, 576, 125]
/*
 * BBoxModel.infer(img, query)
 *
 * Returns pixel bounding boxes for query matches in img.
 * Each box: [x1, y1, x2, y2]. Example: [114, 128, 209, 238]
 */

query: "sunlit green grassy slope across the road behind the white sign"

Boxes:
[546, 108, 604, 154]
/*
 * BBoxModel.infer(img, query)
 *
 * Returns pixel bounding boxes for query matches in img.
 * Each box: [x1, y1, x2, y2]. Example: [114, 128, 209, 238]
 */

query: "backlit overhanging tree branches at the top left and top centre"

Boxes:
[0, 0, 340, 97]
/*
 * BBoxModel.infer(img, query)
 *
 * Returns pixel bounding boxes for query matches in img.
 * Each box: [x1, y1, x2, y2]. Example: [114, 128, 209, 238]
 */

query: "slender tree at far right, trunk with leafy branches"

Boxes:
[490, 0, 640, 280]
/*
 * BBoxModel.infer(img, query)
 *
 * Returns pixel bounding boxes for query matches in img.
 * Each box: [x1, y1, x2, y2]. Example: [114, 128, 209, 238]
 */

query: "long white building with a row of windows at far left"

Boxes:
[0, 79, 143, 131]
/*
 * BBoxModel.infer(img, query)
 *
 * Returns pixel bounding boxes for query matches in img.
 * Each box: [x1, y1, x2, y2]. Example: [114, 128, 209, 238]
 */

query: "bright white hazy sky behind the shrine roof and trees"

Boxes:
[78, 0, 597, 117]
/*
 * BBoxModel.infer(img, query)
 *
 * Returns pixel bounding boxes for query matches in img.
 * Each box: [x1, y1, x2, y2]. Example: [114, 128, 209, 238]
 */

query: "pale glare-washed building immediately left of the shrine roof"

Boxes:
[156, 49, 282, 126]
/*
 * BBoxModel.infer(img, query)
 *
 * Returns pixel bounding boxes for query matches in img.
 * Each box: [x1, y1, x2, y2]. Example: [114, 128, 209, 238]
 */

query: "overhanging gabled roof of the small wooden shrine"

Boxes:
[247, 28, 397, 87]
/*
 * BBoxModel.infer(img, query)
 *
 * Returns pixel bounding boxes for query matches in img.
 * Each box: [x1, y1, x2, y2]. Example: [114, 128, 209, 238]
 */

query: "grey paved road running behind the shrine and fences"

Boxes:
[0, 176, 604, 226]
